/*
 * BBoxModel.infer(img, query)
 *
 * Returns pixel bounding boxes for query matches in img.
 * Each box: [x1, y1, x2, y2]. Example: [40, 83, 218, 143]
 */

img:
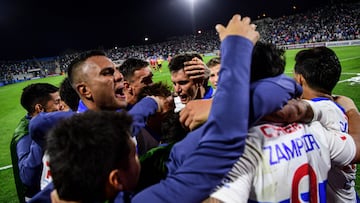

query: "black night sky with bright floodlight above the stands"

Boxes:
[0, 0, 329, 61]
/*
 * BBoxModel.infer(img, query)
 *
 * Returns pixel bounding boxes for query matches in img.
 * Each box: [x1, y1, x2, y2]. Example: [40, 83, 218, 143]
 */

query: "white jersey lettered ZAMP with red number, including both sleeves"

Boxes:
[211, 121, 356, 202]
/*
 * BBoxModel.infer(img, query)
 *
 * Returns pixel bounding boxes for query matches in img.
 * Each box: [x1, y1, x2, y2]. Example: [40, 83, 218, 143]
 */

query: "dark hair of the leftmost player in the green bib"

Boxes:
[20, 83, 59, 114]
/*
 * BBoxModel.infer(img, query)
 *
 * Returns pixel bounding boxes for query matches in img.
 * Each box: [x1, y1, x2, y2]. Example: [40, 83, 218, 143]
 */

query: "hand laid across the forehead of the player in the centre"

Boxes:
[184, 57, 210, 80]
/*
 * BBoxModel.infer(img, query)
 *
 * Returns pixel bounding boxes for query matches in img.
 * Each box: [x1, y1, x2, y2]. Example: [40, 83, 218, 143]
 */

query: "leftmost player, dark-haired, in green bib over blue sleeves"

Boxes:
[10, 83, 63, 202]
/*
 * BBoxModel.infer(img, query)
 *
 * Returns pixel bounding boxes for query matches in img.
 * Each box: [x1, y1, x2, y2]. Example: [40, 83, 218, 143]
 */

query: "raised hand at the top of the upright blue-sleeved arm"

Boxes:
[215, 14, 260, 44]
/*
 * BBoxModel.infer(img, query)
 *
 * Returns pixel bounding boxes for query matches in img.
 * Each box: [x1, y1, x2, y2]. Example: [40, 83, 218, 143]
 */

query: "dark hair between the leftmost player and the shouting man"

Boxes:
[59, 77, 80, 111]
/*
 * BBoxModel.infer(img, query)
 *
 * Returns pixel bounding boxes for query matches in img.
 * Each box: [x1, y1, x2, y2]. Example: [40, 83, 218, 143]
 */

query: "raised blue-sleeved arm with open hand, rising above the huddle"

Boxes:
[38, 15, 259, 203]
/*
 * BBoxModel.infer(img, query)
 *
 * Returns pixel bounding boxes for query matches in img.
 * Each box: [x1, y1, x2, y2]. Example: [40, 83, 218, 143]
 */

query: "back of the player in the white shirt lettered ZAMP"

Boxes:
[249, 122, 355, 202]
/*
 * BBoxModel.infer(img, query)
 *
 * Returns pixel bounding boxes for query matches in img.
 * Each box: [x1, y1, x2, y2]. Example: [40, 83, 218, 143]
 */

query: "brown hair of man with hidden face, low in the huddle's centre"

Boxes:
[137, 82, 172, 101]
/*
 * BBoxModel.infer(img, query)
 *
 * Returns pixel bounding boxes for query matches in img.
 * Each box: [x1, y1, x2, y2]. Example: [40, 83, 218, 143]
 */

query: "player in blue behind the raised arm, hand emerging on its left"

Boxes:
[180, 42, 302, 129]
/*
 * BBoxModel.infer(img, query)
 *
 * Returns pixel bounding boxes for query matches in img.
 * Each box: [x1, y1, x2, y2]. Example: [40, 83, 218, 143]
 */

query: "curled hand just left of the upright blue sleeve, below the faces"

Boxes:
[180, 99, 212, 130]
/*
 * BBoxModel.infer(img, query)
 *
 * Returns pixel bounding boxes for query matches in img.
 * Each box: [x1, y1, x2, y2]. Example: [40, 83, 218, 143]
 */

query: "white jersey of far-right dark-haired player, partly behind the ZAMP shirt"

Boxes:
[309, 98, 356, 203]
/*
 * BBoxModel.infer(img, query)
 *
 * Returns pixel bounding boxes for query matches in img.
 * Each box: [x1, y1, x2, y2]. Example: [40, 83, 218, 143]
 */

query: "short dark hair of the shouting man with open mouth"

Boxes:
[67, 50, 106, 85]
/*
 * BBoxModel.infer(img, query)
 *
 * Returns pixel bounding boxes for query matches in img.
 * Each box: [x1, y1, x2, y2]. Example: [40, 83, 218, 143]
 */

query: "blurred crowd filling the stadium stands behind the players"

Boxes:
[0, 3, 360, 86]
